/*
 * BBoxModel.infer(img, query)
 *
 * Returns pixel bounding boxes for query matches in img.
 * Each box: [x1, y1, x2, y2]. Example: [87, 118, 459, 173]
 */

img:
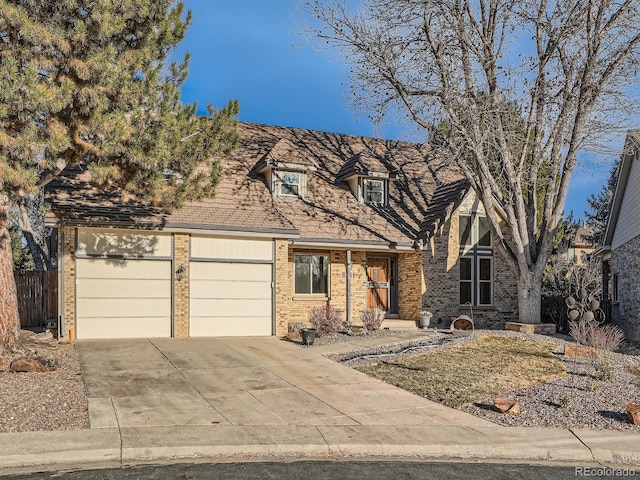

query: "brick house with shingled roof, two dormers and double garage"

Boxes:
[47, 123, 518, 339]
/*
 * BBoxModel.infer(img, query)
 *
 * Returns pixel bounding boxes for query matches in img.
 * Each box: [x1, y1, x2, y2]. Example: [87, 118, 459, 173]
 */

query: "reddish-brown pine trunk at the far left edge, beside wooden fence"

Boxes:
[0, 200, 20, 353]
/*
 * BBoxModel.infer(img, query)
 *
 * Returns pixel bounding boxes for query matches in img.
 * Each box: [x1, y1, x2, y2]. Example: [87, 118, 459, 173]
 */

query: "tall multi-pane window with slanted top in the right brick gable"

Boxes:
[459, 213, 493, 306]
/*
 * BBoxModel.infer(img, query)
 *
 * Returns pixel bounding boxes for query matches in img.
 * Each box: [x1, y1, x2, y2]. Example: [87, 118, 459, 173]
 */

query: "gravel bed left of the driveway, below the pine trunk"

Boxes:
[0, 330, 89, 432]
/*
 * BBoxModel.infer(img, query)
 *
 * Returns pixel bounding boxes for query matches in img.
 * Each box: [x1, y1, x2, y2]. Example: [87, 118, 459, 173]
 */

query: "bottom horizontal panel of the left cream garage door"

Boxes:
[78, 317, 171, 339]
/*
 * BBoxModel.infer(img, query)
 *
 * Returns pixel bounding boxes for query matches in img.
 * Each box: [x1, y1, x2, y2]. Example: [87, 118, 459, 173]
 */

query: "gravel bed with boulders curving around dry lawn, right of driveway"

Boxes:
[324, 330, 640, 432]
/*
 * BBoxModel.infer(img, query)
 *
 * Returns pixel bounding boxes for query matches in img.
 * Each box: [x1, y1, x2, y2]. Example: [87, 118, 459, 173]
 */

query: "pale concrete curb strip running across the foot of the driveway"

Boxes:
[0, 425, 640, 475]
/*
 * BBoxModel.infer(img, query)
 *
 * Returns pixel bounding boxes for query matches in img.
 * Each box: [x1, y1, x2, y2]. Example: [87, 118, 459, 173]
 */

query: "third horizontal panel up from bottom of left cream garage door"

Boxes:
[76, 278, 171, 299]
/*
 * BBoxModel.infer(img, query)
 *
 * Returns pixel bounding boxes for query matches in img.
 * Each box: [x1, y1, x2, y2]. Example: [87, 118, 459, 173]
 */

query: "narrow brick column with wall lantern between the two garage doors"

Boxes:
[173, 233, 189, 338]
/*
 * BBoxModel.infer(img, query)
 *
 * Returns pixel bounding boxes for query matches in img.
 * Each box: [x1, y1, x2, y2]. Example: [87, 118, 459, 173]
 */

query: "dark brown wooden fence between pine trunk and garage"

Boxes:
[14, 270, 58, 328]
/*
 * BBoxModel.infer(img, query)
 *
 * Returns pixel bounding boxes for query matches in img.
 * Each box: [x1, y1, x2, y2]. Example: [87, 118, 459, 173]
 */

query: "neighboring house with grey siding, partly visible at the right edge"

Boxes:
[597, 130, 640, 341]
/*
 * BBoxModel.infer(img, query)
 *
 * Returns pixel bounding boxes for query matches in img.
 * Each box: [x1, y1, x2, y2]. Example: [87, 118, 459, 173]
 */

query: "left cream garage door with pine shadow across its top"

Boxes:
[76, 229, 172, 339]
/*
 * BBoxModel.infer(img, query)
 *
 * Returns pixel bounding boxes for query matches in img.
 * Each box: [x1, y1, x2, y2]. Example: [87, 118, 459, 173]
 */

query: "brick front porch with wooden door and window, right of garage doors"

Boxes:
[275, 242, 425, 336]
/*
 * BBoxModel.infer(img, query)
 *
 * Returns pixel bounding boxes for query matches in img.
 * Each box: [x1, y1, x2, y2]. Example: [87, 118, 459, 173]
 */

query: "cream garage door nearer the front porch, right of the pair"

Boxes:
[189, 236, 273, 337]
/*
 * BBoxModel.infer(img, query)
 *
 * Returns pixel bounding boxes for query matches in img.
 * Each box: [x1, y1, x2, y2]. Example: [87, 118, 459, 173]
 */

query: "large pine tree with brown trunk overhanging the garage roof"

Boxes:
[0, 0, 238, 348]
